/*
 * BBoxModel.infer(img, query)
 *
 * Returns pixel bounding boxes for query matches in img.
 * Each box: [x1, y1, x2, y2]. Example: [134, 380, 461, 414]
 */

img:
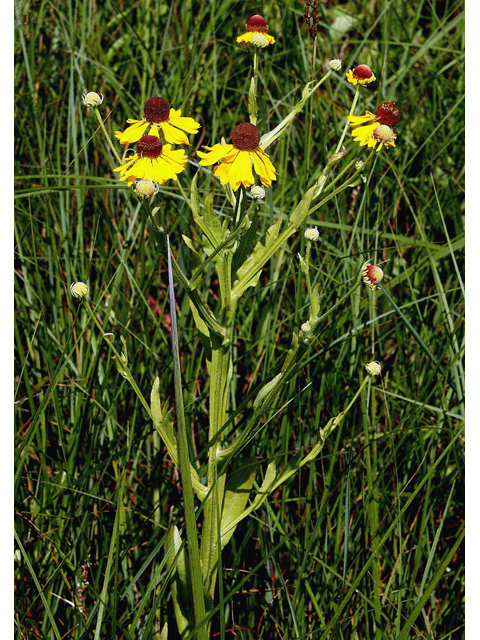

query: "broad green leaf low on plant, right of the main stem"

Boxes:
[220, 458, 261, 549]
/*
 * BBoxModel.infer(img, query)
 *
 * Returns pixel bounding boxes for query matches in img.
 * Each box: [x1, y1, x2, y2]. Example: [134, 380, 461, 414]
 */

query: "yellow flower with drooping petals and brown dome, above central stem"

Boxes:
[197, 122, 277, 191]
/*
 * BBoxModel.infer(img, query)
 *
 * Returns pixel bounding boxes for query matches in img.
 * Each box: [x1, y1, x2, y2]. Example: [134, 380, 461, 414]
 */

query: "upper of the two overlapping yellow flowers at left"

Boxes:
[115, 97, 200, 144]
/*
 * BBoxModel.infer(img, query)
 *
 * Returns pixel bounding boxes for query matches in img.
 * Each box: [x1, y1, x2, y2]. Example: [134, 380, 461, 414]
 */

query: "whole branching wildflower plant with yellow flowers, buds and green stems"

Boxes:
[79, 16, 408, 638]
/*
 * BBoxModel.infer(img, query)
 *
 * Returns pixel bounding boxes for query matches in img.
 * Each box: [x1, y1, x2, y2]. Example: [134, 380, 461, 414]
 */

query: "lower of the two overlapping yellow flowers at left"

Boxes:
[114, 135, 187, 186]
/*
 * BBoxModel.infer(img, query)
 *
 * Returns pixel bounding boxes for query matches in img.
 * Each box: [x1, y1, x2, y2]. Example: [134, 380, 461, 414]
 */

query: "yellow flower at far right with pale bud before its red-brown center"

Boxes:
[348, 102, 400, 151]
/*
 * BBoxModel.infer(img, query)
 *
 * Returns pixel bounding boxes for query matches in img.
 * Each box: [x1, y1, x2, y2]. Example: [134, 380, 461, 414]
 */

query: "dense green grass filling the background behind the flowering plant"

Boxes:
[14, 0, 465, 640]
